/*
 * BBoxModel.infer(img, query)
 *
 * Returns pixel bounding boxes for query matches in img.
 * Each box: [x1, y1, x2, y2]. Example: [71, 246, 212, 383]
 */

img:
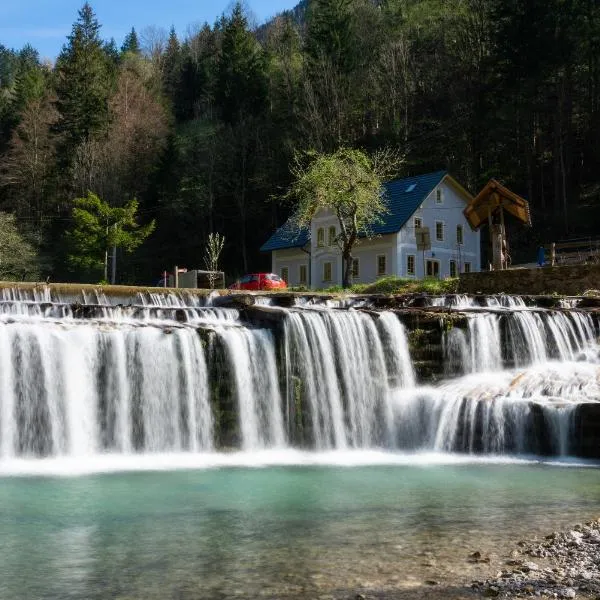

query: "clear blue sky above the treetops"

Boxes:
[0, 0, 298, 59]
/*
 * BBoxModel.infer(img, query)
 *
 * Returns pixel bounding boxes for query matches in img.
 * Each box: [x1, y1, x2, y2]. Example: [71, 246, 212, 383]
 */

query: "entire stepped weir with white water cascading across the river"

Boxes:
[0, 287, 600, 462]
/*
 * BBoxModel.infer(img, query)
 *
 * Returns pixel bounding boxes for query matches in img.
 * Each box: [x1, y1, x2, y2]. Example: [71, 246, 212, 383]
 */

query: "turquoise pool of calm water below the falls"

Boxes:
[0, 463, 600, 600]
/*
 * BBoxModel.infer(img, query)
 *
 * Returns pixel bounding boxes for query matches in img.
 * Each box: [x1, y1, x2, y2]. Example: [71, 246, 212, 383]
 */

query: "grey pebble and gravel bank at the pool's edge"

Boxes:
[470, 519, 600, 600]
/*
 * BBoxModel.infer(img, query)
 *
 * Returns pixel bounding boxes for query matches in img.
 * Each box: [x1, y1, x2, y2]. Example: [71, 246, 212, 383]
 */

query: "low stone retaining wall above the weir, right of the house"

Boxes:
[459, 265, 600, 296]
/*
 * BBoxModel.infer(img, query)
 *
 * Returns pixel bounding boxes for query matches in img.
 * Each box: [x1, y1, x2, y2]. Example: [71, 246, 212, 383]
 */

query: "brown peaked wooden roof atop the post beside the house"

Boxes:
[463, 179, 531, 229]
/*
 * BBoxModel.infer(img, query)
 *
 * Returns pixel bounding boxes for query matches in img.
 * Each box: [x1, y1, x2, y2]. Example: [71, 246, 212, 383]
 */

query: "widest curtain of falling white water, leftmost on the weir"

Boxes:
[0, 322, 212, 457]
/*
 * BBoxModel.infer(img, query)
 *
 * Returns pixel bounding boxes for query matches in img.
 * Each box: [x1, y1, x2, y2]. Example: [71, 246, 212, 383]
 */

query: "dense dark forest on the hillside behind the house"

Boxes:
[0, 0, 600, 285]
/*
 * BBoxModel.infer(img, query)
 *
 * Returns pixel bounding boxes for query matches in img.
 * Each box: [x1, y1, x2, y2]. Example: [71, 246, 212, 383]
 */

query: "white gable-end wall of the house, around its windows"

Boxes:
[397, 178, 481, 279]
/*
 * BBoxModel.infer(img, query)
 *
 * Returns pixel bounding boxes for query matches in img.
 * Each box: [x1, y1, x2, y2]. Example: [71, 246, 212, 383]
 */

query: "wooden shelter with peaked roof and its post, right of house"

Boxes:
[464, 179, 531, 270]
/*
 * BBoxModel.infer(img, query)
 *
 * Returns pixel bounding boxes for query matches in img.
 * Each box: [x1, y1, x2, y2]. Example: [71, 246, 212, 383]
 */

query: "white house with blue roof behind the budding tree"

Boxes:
[261, 171, 481, 289]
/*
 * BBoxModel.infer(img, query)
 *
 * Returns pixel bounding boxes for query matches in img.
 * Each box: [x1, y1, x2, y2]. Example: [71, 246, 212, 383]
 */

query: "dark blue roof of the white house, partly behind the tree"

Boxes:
[261, 171, 446, 252]
